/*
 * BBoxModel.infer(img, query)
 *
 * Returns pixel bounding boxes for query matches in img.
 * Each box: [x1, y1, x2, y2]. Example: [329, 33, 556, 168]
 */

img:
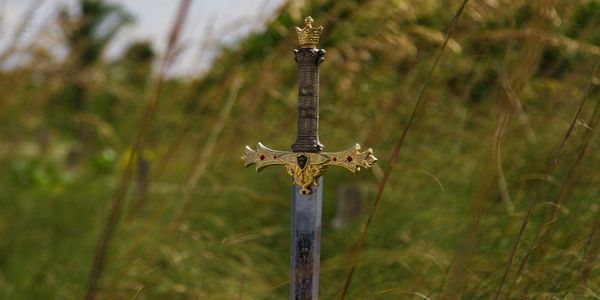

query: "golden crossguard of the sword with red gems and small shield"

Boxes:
[242, 143, 377, 195]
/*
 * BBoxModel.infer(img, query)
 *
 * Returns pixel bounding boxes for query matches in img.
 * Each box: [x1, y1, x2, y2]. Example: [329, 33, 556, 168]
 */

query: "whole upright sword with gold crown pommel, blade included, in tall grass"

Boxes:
[242, 17, 377, 300]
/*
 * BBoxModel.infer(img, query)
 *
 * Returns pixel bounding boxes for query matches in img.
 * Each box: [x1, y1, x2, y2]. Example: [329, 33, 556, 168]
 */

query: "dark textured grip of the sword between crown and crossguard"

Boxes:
[292, 48, 325, 152]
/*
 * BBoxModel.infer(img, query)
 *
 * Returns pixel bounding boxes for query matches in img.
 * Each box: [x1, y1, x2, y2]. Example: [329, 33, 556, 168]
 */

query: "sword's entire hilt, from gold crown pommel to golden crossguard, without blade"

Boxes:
[242, 17, 377, 195]
